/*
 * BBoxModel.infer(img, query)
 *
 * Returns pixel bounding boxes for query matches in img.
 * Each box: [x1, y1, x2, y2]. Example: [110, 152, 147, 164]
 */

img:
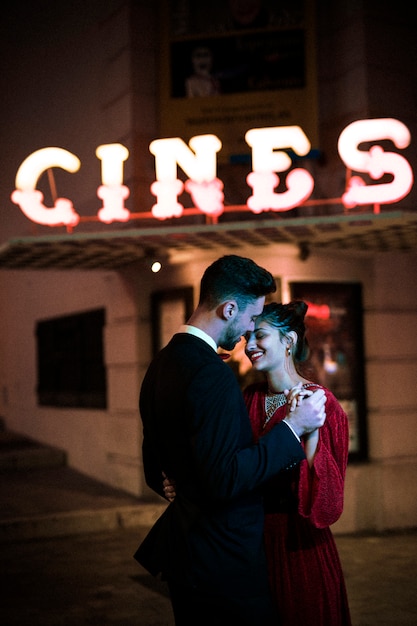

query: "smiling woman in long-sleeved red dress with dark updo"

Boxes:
[244, 301, 351, 626]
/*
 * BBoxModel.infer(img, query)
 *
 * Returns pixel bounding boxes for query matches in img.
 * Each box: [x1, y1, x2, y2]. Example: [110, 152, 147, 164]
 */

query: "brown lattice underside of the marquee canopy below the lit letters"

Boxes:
[0, 211, 417, 269]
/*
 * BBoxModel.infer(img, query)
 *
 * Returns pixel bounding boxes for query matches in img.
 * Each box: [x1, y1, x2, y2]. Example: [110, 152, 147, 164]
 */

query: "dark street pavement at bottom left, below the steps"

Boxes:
[0, 528, 174, 626]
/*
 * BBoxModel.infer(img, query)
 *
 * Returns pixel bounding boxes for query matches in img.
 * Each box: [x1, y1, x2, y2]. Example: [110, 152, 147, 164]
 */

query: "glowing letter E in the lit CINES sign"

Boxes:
[245, 126, 314, 213]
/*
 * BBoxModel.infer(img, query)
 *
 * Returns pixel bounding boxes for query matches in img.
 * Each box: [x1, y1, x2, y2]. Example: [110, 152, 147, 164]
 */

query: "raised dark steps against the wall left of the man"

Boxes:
[0, 429, 165, 545]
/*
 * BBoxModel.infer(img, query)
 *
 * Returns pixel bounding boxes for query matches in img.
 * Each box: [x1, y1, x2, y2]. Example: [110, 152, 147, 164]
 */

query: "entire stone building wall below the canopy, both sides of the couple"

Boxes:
[0, 241, 417, 532]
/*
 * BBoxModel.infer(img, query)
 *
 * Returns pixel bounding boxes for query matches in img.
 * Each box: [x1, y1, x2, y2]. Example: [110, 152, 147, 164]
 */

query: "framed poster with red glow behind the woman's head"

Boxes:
[289, 282, 367, 460]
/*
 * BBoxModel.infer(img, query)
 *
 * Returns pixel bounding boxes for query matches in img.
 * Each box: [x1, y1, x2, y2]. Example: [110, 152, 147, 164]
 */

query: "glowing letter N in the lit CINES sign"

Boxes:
[149, 135, 224, 219]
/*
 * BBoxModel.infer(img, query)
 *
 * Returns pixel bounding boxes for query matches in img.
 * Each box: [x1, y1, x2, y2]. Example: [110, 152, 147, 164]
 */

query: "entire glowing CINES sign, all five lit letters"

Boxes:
[11, 118, 413, 228]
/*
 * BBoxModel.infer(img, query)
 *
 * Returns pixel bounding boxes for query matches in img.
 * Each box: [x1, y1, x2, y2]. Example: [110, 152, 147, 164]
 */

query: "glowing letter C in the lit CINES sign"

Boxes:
[11, 147, 81, 226]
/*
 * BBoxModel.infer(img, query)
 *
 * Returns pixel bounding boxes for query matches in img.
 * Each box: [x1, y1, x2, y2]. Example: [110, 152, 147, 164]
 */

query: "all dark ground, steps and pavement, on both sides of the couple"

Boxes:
[0, 431, 417, 626]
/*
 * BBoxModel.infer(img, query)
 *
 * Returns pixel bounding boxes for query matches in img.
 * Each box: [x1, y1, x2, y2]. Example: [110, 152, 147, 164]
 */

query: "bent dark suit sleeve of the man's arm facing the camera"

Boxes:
[187, 364, 305, 499]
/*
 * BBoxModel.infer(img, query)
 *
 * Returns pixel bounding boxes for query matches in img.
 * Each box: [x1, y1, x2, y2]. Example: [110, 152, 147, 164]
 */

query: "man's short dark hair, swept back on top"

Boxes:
[199, 254, 277, 310]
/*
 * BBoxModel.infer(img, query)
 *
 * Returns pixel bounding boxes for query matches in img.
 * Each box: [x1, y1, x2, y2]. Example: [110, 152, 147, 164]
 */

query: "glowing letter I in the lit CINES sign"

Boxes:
[96, 143, 130, 224]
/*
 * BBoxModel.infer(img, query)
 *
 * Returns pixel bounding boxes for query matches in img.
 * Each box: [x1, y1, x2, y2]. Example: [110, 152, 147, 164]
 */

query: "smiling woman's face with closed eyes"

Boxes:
[245, 321, 286, 372]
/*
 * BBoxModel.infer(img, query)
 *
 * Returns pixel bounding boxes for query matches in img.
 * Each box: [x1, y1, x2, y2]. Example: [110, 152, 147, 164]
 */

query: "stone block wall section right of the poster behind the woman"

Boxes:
[335, 253, 417, 532]
